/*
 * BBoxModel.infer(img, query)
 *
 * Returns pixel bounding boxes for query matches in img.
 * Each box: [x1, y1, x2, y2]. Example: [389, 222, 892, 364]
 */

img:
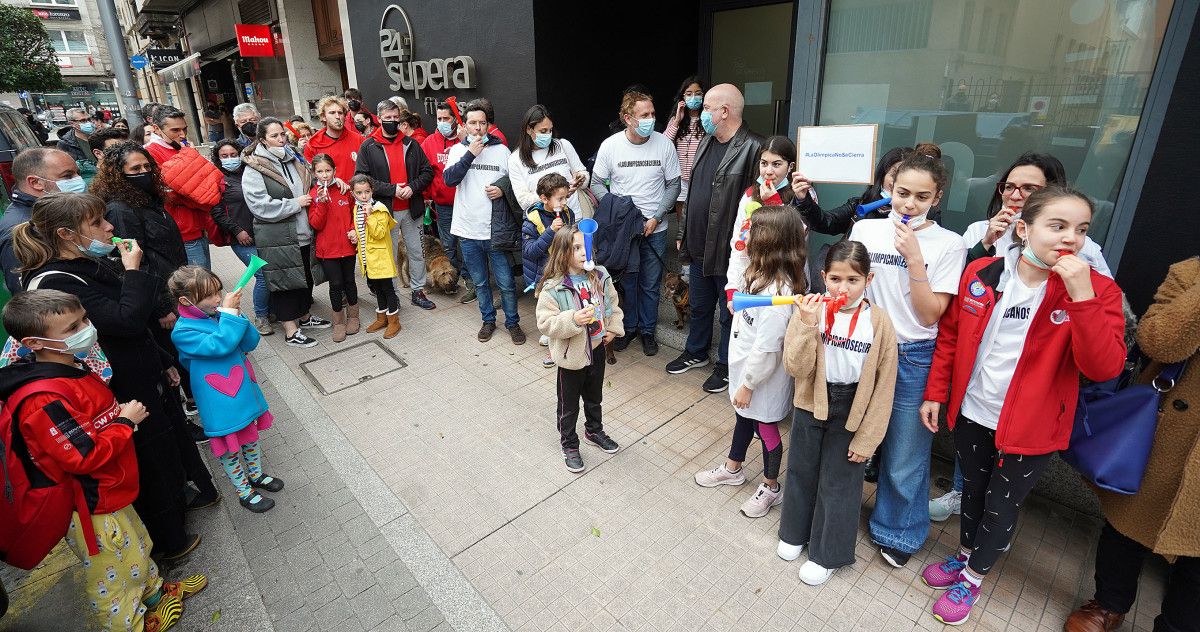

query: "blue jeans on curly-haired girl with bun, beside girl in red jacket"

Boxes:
[870, 341, 936, 553]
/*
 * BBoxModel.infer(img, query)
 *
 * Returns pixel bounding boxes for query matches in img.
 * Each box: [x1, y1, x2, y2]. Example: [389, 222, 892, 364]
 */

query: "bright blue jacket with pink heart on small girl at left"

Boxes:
[170, 307, 266, 437]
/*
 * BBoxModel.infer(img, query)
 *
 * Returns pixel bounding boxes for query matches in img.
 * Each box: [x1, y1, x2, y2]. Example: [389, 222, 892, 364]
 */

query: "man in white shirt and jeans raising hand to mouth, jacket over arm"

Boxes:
[442, 103, 526, 344]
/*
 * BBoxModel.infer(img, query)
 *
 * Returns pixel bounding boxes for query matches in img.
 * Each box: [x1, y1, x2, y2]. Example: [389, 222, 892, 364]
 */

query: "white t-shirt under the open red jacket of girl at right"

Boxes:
[952, 271, 1046, 429]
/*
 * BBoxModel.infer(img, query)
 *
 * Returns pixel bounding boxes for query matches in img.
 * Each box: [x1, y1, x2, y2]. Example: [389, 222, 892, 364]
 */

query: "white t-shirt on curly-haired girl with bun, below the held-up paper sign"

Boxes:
[850, 217, 967, 343]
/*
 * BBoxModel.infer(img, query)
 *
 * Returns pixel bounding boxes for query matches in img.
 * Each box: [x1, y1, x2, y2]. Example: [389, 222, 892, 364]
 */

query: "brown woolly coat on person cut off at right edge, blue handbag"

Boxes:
[1098, 258, 1200, 558]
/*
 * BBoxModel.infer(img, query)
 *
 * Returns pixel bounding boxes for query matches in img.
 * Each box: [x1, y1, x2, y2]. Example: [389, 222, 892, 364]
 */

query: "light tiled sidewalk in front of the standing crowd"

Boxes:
[0, 249, 1163, 632]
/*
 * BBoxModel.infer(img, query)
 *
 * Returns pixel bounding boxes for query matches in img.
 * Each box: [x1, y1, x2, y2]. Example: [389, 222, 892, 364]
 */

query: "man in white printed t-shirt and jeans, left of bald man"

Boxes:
[592, 92, 680, 355]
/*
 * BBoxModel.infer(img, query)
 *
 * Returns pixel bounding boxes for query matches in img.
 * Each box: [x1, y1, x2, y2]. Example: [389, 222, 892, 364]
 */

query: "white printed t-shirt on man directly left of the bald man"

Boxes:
[592, 130, 680, 233]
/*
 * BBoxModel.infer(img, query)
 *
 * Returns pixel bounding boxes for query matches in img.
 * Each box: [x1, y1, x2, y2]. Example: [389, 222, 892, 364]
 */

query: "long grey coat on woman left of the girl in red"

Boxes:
[241, 143, 325, 291]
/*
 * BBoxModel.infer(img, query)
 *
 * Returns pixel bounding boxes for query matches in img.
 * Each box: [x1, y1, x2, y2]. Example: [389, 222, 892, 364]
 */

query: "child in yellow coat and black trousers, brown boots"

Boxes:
[348, 174, 400, 338]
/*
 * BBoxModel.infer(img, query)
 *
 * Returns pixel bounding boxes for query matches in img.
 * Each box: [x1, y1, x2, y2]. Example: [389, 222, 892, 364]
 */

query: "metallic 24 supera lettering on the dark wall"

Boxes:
[379, 5, 479, 98]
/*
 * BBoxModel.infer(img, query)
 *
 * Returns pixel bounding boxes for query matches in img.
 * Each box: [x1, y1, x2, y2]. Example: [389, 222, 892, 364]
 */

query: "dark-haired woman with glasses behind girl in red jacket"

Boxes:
[962, 151, 1112, 278]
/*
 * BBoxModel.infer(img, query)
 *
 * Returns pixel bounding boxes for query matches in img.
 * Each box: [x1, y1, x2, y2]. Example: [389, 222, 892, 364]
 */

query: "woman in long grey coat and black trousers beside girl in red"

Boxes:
[241, 118, 330, 348]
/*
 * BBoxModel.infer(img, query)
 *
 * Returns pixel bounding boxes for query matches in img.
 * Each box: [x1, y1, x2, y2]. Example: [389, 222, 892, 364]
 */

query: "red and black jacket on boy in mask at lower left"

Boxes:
[0, 362, 138, 513]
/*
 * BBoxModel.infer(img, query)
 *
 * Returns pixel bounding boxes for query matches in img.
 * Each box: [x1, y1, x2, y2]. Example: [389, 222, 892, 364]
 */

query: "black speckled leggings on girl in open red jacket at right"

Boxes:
[954, 415, 1050, 576]
